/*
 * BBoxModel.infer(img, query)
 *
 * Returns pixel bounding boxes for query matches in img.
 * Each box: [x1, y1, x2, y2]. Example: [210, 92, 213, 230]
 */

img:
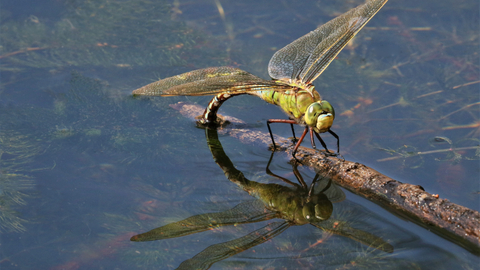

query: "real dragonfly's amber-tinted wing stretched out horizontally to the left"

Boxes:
[132, 67, 287, 96]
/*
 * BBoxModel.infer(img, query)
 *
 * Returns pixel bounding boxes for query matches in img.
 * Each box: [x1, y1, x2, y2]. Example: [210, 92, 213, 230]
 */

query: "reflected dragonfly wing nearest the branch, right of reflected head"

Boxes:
[311, 219, 393, 253]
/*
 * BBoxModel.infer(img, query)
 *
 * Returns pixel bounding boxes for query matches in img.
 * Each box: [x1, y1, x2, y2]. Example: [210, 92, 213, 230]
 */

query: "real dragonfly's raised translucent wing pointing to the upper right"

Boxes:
[268, 0, 388, 84]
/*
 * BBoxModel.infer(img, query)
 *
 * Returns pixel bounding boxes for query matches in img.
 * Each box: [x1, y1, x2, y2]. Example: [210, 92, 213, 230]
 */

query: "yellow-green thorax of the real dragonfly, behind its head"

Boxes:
[256, 85, 321, 122]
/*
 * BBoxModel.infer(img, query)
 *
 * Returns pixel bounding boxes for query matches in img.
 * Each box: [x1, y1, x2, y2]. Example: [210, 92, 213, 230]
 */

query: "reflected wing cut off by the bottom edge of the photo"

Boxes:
[177, 221, 290, 270]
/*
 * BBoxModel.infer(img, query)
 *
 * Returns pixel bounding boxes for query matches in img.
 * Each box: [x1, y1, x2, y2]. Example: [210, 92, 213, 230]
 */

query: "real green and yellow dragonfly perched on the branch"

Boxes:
[132, 0, 388, 159]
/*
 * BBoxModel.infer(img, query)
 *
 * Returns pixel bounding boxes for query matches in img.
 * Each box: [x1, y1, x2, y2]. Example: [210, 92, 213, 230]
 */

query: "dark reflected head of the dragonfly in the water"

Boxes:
[302, 194, 333, 222]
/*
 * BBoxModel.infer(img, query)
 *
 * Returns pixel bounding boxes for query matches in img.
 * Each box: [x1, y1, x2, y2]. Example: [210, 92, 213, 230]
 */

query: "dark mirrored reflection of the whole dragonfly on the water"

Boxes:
[130, 129, 393, 269]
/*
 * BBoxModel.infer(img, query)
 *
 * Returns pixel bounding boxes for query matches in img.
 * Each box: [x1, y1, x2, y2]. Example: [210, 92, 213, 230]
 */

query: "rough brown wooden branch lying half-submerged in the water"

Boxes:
[171, 103, 480, 255]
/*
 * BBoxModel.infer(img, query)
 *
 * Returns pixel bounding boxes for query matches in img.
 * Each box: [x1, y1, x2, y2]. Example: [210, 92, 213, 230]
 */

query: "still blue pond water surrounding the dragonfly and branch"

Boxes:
[0, 0, 480, 269]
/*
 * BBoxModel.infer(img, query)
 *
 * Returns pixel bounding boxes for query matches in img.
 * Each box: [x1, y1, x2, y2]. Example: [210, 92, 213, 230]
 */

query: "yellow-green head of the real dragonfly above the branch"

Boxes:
[305, 100, 335, 133]
